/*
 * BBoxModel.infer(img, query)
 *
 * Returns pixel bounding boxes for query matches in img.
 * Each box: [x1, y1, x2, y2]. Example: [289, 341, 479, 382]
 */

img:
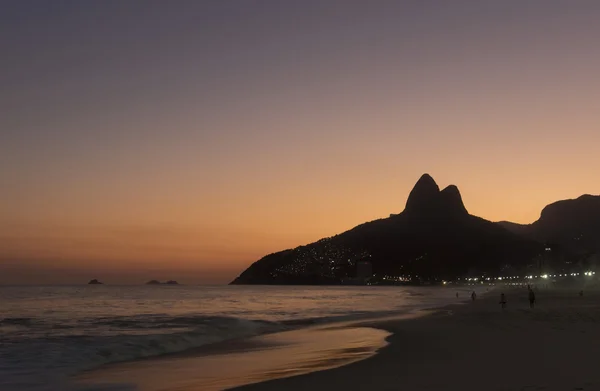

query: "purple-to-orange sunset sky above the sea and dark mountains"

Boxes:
[0, 0, 600, 284]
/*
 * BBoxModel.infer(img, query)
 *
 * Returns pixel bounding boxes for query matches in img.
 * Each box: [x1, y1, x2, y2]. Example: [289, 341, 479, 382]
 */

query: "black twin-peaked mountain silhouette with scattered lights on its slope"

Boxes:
[232, 174, 600, 284]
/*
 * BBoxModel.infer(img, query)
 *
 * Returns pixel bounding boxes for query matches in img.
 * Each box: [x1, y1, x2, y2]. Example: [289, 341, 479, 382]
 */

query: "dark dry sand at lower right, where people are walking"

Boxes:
[233, 288, 600, 391]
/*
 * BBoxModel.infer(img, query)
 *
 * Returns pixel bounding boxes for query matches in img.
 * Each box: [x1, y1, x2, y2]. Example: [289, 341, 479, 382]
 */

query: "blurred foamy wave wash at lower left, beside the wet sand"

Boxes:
[0, 316, 282, 391]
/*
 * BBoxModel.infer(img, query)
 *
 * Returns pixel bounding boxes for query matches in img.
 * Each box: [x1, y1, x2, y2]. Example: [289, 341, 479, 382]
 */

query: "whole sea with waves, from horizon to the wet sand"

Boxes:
[0, 285, 478, 391]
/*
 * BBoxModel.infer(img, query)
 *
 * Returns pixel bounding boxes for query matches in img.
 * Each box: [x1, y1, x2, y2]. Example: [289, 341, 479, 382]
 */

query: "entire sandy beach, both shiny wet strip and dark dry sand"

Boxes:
[76, 288, 600, 391]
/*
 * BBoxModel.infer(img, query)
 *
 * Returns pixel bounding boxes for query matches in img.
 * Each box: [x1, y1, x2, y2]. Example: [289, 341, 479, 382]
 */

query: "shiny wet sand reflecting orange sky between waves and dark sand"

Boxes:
[73, 290, 485, 391]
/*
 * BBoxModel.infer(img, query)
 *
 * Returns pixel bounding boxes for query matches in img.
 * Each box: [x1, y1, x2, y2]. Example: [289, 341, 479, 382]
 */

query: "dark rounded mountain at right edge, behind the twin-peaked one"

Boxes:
[498, 194, 600, 255]
